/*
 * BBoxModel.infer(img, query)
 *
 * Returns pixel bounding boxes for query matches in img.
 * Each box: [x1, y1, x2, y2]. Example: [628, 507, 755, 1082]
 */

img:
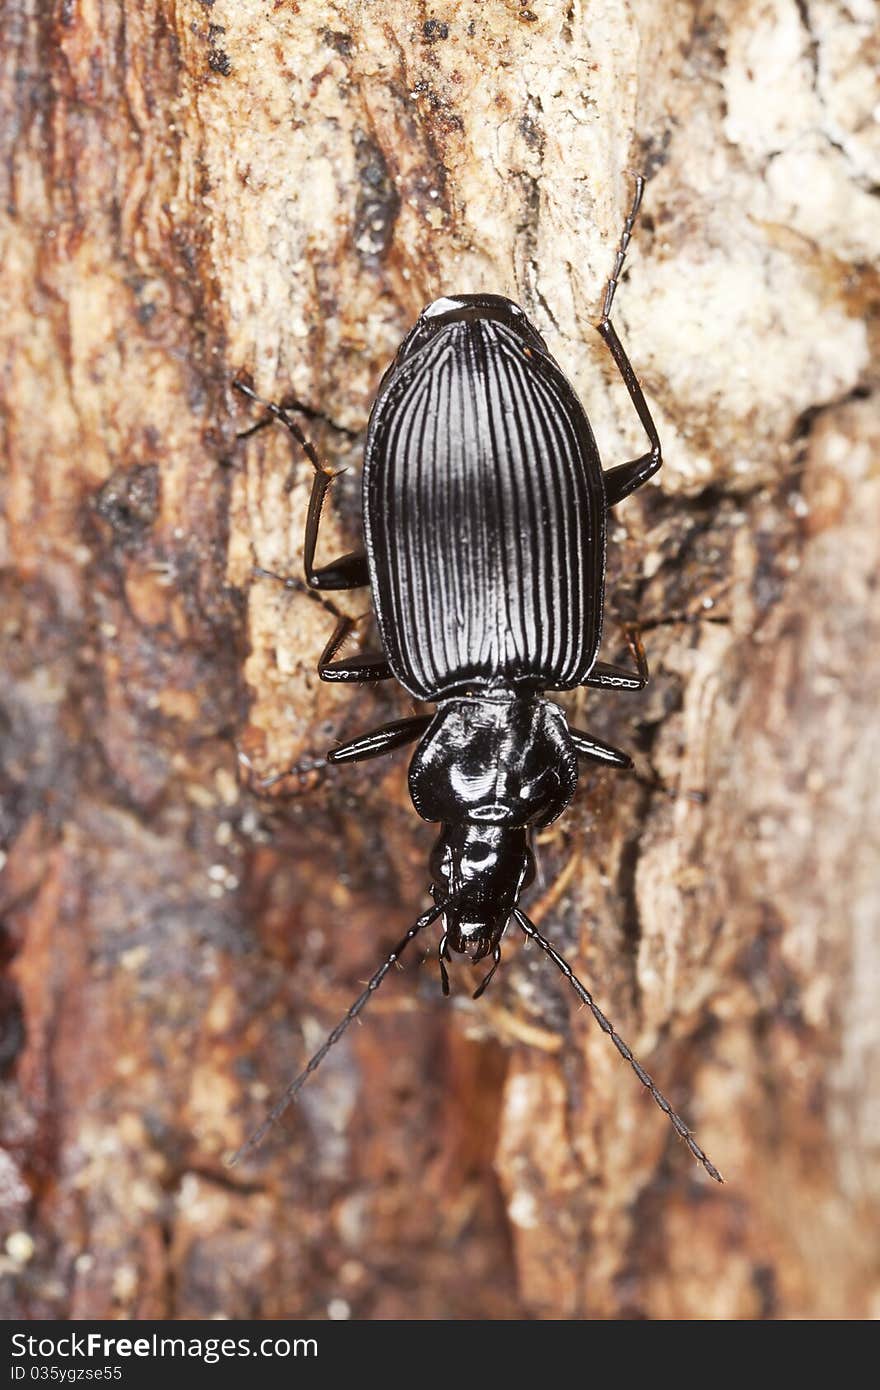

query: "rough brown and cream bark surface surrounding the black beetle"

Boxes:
[0, 0, 880, 1319]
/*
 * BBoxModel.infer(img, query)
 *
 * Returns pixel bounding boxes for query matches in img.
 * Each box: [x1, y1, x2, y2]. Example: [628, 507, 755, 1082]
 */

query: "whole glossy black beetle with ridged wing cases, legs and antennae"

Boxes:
[235, 178, 722, 1182]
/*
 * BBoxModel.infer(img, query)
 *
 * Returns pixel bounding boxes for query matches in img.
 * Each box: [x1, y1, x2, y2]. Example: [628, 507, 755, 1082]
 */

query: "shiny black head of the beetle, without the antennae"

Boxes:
[431, 821, 535, 960]
